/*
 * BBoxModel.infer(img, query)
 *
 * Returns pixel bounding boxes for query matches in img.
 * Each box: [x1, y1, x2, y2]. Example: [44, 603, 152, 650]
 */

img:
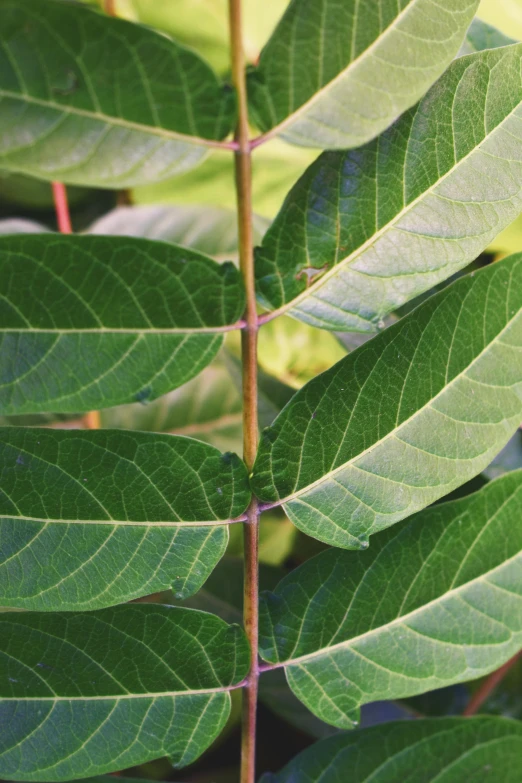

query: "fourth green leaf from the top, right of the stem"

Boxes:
[260, 471, 522, 728]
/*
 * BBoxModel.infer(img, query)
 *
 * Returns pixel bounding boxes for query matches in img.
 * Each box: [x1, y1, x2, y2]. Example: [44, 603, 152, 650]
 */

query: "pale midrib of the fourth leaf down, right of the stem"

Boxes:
[265, 552, 522, 669]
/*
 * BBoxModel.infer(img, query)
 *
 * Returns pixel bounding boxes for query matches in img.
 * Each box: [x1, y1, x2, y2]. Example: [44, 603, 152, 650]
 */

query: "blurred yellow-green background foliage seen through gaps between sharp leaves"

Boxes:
[0, 0, 522, 783]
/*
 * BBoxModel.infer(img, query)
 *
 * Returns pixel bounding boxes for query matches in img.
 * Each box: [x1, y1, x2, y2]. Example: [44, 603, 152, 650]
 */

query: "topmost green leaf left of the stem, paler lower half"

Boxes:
[0, 0, 234, 188]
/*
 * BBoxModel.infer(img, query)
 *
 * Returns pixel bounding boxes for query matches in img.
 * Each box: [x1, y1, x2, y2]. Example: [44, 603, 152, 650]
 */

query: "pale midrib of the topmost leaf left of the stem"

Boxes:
[0, 89, 228, 149]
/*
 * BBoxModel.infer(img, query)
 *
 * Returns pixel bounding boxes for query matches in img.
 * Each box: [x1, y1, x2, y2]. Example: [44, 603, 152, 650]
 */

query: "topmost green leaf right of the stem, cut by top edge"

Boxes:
[249, 0, 478, 149]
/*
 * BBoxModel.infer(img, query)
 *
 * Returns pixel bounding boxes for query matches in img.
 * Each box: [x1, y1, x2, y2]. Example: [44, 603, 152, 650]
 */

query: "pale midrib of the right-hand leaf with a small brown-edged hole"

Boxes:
[267, 43, 522, 320]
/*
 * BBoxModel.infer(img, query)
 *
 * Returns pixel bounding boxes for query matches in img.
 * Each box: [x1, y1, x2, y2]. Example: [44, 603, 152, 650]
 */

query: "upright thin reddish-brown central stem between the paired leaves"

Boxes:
[229, 0, 259, 783]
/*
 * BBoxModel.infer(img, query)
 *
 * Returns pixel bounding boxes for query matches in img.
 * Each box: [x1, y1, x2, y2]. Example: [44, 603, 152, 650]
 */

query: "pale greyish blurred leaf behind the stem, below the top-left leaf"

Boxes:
[89, 205, 268, 259]
